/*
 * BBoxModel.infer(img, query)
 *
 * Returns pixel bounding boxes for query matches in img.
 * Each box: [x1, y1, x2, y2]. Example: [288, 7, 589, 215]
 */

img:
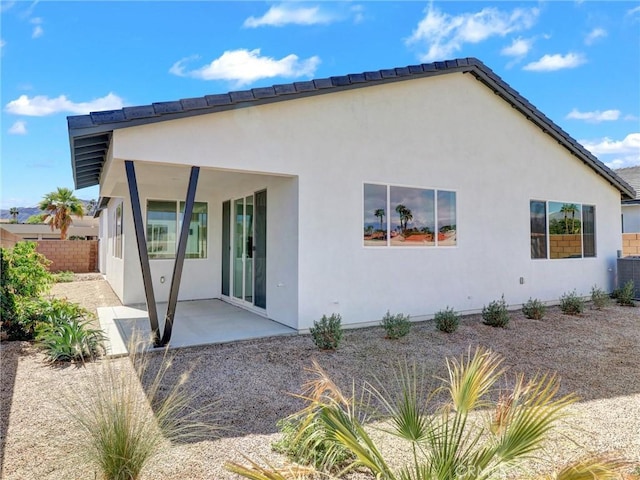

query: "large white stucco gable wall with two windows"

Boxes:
[107, 74, 621, 330]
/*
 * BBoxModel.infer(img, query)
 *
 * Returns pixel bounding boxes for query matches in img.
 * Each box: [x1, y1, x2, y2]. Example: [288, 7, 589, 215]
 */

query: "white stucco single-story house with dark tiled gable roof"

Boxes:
[68, 58, 635, 344]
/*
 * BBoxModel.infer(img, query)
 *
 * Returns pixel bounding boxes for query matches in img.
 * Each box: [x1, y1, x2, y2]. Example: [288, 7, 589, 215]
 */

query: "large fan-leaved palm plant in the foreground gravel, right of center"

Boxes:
[227, 348, 604, 480]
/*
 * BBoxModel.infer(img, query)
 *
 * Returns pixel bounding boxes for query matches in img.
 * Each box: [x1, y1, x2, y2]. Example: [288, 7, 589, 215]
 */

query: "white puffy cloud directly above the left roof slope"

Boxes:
[169, 48, 320, 87]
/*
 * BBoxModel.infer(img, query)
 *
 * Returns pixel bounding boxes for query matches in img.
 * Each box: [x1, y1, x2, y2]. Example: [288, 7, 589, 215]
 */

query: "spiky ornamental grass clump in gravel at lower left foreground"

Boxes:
[66, 341, 216, 480]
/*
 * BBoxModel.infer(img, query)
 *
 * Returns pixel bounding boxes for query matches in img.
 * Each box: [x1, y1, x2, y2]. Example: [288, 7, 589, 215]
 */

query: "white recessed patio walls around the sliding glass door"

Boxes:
[100, 162, 298, 328]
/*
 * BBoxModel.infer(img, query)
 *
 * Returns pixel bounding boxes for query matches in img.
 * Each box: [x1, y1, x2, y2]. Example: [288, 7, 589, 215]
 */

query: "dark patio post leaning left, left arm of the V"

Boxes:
[124, 160, 160, 347]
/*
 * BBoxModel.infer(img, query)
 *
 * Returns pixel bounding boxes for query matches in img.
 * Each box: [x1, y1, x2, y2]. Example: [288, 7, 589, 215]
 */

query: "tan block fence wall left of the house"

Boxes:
[35, 240, 98, 273]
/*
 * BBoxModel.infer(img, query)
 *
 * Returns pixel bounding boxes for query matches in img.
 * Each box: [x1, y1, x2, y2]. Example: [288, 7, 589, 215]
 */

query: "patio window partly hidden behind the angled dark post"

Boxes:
[147, 200, 207, 259]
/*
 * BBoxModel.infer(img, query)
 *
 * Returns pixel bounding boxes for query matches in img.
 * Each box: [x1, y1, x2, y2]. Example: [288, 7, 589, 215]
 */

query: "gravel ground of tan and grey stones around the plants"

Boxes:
[0, 279, 640, 480]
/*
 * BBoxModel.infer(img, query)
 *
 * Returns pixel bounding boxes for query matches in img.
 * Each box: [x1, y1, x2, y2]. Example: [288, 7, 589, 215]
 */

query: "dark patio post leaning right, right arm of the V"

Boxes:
[160, 167, 200, 346]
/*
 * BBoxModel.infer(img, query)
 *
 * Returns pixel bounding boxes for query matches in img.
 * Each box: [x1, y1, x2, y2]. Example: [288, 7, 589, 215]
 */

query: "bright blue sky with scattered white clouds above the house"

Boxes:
[0, 0, 640, 208]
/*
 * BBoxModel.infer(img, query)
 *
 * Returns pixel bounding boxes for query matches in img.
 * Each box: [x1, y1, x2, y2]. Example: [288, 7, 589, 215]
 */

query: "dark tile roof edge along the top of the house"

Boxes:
[67, 58, 636, 198]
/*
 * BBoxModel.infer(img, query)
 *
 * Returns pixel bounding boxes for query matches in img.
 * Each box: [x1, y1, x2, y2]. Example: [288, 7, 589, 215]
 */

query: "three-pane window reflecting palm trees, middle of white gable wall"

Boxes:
[363, 183, 457, 247]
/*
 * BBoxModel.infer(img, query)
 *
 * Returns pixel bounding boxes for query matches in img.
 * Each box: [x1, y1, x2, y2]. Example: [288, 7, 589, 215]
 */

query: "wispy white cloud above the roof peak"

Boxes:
[406, 4, 539, 62]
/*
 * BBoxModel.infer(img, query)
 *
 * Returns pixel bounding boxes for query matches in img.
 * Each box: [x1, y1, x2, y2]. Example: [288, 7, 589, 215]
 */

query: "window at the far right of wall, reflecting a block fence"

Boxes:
[529, 200, 596, 259]
